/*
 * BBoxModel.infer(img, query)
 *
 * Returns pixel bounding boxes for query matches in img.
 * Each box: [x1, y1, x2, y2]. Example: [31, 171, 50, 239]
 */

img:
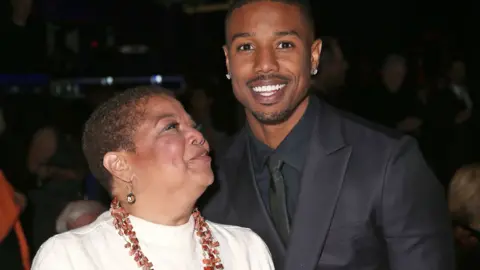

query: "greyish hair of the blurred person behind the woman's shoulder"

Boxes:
[56, 201, 107, 233]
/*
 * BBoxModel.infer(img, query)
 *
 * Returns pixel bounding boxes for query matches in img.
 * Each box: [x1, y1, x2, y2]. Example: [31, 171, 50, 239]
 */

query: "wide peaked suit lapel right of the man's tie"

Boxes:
[285, 104, 351, 270]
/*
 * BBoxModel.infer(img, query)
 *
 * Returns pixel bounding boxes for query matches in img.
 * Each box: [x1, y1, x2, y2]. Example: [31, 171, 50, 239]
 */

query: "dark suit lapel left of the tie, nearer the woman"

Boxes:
[228, 136, 285, 265]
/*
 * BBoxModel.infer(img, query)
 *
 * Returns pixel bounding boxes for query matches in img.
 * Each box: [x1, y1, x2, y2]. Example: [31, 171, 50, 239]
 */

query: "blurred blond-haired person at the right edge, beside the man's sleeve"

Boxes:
[448, 164, 480, 270]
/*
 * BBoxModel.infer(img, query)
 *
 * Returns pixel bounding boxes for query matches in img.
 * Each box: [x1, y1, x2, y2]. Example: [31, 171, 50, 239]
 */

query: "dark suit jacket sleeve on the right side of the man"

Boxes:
[380, 138, 454, 270]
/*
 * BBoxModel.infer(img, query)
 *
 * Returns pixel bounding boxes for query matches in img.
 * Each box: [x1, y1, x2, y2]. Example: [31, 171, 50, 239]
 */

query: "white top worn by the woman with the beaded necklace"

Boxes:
[32, 211, 274, 270]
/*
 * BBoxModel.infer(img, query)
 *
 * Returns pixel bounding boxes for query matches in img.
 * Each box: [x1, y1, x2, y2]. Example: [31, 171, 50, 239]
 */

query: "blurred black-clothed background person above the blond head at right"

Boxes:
[428, 58, 477, 186]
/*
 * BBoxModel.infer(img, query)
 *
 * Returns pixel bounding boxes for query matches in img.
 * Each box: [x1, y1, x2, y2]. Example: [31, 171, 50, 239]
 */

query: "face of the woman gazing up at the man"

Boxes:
[117, 96, 213, 205]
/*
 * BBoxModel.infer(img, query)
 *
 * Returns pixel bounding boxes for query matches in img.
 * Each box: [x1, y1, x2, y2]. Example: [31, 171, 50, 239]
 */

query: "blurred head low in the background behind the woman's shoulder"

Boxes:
[56, 200, 107, 233]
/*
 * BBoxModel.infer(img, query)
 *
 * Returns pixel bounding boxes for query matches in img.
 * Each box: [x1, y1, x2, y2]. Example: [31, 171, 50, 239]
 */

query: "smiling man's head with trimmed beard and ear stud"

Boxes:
[224, 1, 321, 124]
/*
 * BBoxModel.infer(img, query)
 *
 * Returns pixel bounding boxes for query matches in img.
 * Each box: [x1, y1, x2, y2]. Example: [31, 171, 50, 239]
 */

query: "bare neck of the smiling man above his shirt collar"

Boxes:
[247, 96, 309, 149]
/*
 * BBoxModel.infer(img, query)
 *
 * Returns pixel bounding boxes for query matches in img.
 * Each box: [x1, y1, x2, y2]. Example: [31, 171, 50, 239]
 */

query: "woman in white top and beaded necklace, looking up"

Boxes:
[32, 87, 273, 270]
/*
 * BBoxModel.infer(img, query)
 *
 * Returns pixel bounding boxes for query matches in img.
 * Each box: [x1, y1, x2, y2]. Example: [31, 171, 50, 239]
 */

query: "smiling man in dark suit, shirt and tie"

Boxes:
[204, 0, 454, 270]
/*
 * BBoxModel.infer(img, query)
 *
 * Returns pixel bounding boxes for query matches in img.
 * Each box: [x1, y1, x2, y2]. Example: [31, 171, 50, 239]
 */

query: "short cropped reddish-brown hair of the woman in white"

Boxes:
[82, 86, 173, 192]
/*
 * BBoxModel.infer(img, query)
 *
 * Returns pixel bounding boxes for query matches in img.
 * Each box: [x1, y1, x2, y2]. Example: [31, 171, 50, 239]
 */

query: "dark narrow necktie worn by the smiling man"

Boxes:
[268, 156, 290, 244]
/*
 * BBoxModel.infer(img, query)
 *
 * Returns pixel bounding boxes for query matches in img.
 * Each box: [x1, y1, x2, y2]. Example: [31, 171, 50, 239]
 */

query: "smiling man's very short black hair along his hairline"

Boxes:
[225, 0, 315, 43]
